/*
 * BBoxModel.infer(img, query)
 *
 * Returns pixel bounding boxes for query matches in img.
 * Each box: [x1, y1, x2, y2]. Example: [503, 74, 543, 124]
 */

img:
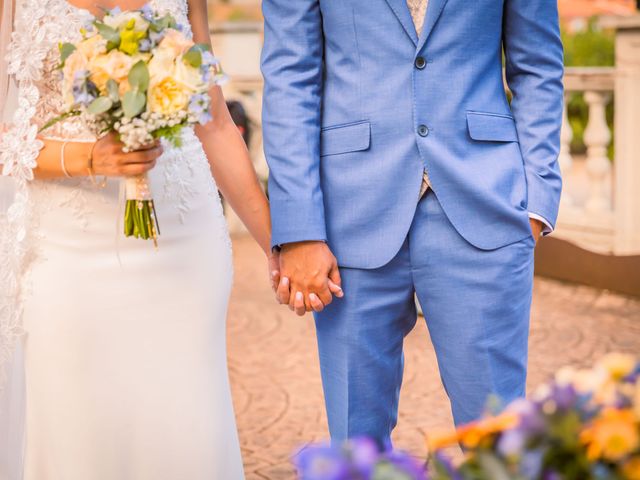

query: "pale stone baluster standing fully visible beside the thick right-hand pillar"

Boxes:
[584, 91, 611, 214]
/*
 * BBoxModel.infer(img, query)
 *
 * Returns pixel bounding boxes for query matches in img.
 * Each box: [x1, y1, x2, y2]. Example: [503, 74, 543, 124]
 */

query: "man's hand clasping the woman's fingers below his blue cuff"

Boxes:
[278, 241, 343, 316]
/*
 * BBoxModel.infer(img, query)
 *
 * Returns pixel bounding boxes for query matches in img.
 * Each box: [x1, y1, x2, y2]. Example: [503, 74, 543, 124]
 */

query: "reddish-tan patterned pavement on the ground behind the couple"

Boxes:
[225, 237, 640, 480]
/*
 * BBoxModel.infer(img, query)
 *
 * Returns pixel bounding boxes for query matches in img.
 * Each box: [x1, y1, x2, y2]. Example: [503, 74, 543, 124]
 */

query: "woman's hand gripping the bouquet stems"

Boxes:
[92, 133, 162, 177]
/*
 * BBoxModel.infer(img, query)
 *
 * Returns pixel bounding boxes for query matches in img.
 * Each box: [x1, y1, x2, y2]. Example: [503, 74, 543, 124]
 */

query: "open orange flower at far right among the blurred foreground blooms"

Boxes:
[580, 408, 640, 462]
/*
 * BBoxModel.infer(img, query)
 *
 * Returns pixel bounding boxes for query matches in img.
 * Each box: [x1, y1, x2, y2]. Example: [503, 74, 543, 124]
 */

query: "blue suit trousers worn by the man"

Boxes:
[316, 190, 535, 444]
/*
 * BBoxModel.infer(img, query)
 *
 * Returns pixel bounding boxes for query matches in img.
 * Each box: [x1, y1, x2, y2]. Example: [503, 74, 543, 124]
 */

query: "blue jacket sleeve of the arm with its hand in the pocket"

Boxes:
[503, 0, 564, 227]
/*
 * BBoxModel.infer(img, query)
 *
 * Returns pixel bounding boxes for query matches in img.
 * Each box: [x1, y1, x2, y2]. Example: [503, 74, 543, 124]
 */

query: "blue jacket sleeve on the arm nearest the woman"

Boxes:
[262, 0, 326, 246]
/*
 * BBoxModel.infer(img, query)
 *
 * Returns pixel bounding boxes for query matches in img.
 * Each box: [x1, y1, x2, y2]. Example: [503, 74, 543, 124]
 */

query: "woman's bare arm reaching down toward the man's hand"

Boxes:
[189, 0, 271, 255]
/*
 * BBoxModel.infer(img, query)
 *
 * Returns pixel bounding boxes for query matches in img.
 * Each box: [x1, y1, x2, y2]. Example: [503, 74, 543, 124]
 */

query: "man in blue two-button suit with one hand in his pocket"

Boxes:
[262, 0, 563, 443]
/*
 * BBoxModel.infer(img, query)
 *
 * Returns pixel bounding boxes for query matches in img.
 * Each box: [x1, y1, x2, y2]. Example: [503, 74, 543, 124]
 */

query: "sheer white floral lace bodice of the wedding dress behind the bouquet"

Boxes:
[33, 0, 189, 141]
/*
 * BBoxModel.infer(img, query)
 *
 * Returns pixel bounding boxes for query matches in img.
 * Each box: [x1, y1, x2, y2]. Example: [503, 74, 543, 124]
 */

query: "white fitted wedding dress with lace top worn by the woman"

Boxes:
[0, 0, 244, 480]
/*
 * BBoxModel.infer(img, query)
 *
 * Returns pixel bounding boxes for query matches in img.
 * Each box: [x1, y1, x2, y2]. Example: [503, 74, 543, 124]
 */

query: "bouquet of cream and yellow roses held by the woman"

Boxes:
[43, 5, 224, 245]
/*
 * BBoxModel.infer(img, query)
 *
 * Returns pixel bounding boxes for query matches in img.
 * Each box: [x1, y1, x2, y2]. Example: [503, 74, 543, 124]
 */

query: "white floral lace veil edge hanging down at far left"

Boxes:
[0, 0, 56, 390]
